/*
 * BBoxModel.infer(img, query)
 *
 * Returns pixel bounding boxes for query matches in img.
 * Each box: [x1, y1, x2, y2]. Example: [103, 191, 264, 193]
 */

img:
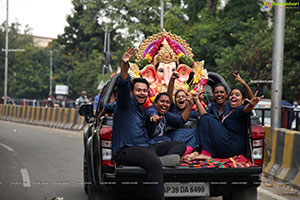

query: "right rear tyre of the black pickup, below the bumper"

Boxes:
[223, 187, 257, 200]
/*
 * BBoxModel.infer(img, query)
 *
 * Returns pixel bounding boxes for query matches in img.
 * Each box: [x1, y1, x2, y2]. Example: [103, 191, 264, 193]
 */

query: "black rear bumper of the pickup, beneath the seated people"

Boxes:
[103, 166, 262, 196]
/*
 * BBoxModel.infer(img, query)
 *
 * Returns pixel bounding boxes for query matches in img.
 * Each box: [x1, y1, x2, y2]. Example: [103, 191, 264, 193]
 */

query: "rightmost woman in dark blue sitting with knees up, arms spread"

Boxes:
[185, 89, 263, 161]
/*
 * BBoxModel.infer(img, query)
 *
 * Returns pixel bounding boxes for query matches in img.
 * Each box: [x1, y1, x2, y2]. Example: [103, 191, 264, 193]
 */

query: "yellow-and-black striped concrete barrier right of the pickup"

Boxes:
[263, 129, 300, 188]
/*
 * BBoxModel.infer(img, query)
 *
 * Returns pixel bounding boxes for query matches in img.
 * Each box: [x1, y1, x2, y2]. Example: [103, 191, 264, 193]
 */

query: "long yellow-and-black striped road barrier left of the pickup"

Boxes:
[0, 104, 86, 130]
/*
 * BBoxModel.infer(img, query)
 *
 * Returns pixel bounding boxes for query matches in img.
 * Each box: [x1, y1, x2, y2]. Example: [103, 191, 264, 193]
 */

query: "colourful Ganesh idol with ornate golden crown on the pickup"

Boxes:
[129, 30, 208, 104]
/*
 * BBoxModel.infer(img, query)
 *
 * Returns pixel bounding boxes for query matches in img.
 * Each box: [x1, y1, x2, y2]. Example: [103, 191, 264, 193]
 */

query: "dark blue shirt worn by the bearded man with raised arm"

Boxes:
[112, 76, 149, 156]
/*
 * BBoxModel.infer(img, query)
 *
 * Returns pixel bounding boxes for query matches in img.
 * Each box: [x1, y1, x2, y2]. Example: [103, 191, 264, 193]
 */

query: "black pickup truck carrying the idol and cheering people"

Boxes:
[79, 72, 264, 200]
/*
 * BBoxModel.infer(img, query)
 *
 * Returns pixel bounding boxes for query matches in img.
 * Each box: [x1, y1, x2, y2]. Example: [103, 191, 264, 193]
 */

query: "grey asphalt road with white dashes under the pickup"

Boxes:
[0, 121, 300, 200]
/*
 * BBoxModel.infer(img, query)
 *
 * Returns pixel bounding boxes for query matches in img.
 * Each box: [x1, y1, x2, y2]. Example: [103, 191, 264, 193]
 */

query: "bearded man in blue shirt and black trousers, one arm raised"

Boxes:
[112, 48, 186, 200]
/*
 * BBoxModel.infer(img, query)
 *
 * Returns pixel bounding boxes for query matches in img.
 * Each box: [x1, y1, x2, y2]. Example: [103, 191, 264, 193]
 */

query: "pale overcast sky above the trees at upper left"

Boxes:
[0, 0, 72, 38]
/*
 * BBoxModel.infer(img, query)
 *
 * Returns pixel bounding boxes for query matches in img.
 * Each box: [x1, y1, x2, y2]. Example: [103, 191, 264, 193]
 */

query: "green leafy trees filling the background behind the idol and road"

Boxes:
[0, 0, 300, 100]
